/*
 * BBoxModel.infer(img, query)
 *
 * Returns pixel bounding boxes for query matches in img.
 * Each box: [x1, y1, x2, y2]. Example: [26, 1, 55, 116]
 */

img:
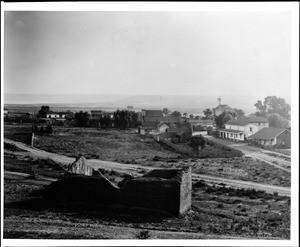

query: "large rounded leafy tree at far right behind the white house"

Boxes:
[254, 96, 291, 119]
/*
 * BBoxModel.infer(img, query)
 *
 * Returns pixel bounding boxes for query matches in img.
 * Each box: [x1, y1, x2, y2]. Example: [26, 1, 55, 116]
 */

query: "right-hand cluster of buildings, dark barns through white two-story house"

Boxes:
[140, 99, 291, 149]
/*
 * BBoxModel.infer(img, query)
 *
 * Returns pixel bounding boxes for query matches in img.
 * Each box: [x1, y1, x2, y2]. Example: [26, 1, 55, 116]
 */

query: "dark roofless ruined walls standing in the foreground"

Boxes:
[46, 168, 192, 216]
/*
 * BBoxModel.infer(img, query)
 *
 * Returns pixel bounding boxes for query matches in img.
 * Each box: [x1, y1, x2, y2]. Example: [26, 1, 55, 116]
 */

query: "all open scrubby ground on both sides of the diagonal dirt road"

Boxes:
[4, 125, 290, 239]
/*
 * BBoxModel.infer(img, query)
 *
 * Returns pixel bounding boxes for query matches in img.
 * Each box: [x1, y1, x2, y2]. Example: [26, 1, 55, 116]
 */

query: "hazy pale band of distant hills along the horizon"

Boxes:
[4, 94, 290, 114]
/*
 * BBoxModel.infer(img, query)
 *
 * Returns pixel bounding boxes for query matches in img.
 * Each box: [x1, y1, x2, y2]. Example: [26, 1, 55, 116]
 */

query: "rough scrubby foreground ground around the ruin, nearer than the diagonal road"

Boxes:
[4, 155, 290, 239]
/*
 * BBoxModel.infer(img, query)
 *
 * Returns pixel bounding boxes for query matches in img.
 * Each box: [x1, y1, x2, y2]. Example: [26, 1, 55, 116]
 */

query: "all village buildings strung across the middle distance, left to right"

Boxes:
[3, 98, 291, 148]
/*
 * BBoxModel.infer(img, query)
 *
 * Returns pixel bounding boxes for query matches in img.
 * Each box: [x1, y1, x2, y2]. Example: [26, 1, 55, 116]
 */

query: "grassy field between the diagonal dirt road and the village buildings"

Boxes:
[5, 125, 291, 186]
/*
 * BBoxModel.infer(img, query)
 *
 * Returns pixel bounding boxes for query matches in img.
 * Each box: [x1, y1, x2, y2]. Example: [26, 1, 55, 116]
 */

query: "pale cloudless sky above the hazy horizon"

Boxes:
[4, 11, 291, 98]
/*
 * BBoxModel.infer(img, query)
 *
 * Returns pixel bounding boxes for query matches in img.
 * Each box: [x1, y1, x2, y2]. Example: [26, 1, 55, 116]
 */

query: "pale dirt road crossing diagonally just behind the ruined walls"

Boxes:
[4, 139, 291, 196]
